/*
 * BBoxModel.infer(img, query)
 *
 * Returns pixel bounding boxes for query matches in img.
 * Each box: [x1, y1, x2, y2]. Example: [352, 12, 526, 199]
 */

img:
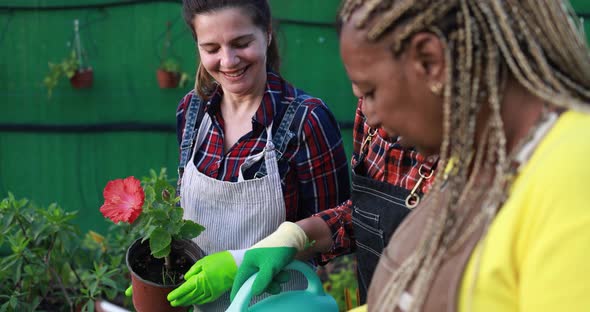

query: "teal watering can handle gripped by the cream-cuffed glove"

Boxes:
[226, 260, 325, 311]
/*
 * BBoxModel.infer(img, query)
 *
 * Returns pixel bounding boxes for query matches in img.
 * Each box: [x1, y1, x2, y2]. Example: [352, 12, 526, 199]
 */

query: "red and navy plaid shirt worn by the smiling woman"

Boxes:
[176, 71, 350, 222]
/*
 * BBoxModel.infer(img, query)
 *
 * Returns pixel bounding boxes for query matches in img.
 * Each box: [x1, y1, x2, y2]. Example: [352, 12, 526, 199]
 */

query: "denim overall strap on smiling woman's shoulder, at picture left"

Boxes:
[176, 94, 201, 195]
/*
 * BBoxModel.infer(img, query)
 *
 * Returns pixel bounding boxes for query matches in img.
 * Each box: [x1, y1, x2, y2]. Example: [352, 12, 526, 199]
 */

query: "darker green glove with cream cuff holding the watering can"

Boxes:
[230, 222, 308, 300]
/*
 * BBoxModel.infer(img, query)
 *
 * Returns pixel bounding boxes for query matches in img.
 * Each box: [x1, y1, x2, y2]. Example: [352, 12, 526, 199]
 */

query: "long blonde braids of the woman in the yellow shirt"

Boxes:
[339, 0, 590, 311]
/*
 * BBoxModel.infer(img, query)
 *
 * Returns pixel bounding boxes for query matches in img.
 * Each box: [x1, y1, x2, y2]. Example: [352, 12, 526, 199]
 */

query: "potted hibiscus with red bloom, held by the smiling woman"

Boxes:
[100, 169, 204, 312]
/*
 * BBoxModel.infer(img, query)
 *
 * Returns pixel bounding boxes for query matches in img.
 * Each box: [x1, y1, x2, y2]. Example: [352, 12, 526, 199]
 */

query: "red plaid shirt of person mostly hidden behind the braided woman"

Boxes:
[316, 99, 436, 263]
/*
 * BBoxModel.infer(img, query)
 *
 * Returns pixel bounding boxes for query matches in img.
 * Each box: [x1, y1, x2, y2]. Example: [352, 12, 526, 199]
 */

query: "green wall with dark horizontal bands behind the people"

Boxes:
[0, 0, 356, 232]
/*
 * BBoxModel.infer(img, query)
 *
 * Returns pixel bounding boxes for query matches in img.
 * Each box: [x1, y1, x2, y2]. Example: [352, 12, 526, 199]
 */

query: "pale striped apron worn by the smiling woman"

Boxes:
[180, 114, 307, 311]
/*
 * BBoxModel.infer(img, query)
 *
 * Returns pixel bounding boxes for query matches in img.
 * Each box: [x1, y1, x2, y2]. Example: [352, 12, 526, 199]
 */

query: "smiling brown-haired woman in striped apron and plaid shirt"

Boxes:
[155, 0, 350, 311]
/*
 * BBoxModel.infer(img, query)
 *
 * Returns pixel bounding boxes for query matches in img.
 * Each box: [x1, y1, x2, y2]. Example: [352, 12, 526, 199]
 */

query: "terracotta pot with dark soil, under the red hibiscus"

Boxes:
[125, 239, 204, 312]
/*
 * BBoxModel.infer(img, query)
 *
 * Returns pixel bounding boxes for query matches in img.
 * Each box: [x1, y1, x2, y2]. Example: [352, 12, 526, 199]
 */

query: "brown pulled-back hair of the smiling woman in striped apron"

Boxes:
[182, 0, 281, 99]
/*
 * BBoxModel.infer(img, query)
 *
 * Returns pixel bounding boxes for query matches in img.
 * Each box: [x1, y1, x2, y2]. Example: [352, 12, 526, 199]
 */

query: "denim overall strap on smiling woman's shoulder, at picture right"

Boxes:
[254, 94, 311, 179]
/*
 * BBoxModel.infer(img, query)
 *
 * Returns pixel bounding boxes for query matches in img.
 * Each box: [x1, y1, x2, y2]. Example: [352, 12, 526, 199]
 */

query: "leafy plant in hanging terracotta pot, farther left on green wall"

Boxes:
[43, 50, 94, 97]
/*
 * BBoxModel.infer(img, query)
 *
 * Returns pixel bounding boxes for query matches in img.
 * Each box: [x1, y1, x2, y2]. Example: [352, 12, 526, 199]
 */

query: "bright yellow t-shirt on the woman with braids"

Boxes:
[459, 112, 590, 312]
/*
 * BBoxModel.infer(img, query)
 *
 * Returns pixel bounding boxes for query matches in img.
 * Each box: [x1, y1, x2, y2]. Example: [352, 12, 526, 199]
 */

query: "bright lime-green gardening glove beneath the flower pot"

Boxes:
[167, 251, 239, 307]
